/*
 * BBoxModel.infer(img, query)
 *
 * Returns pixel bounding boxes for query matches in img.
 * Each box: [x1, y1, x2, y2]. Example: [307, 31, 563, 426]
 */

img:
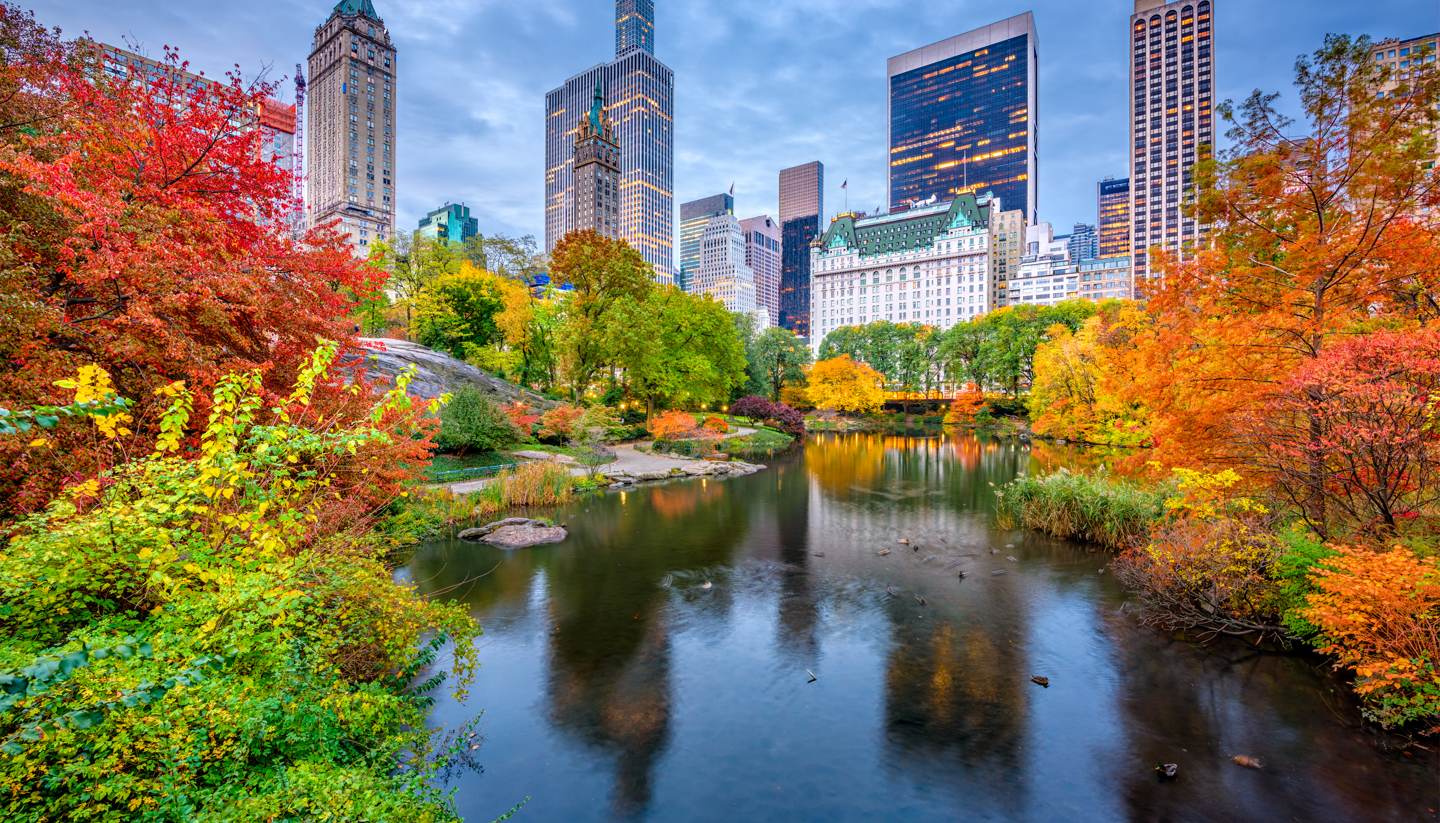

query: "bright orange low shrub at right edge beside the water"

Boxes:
[1300, 547, 1440, 734]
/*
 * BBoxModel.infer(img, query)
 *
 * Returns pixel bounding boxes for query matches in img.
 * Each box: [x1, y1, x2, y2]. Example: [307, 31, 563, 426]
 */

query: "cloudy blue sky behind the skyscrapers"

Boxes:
[17, 0, 1440, 237]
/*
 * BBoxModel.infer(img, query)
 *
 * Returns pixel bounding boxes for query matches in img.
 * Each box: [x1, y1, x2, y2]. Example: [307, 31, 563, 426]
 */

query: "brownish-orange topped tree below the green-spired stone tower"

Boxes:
[550, 230, 654, 400]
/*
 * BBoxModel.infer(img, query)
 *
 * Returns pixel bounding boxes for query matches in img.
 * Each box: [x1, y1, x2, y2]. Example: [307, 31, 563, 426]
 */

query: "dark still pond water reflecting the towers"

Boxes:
[402, 435, 1440, 822]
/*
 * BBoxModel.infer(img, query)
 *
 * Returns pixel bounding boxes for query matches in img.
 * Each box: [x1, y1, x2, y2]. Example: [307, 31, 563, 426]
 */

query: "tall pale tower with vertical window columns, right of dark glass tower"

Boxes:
[1130, 0, 1215, 283]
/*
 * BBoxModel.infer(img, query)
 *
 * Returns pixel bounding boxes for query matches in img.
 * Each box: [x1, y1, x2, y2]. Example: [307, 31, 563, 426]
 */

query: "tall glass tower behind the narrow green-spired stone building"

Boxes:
[544, 0, 675, 283]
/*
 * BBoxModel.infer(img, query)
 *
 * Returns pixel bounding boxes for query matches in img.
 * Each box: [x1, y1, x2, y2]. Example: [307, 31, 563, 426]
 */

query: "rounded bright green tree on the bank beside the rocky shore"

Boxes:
[608, 286, 744, 413]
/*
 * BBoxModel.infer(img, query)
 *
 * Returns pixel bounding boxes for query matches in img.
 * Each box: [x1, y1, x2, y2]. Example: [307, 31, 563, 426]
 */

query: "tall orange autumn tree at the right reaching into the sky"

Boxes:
[1136, 36, 1440, 469]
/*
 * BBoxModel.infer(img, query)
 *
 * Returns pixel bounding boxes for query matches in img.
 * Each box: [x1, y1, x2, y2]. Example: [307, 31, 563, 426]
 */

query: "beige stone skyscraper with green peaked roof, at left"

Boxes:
[305, 0, 399, 256]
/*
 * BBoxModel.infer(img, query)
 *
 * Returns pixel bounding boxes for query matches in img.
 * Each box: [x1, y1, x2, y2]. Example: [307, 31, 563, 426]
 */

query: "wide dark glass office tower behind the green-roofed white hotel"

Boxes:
[888, 12, 1040, 223]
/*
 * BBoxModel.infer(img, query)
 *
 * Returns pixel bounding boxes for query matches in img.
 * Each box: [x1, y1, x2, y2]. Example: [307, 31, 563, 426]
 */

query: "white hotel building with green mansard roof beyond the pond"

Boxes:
[809, 194, 998, 353]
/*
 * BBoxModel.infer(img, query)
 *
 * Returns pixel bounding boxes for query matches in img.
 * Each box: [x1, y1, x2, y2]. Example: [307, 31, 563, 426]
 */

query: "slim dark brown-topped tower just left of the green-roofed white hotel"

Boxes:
[778, 160, 825, 338]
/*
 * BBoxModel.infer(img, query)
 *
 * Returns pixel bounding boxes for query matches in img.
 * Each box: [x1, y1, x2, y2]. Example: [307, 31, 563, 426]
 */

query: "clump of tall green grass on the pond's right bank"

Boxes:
[995, 470, 1166, 550]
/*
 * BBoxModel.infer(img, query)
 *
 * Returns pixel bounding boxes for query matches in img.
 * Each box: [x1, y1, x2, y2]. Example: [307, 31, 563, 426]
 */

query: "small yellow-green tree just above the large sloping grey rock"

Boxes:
[410, 263, 504, 360]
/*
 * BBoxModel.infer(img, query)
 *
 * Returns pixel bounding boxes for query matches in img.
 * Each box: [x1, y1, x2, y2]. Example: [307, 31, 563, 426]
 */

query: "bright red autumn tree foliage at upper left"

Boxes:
[0, 22, 380, 515]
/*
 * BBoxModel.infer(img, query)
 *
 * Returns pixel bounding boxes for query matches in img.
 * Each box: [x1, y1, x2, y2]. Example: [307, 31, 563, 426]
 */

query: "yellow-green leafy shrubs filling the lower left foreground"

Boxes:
[0, 352, 477, 820]
